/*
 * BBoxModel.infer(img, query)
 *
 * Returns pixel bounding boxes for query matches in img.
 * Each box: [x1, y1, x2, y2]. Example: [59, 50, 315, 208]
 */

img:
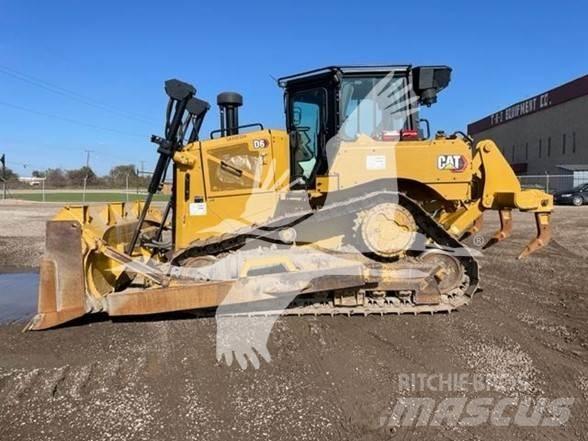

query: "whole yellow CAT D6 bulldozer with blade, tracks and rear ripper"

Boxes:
[27, 65, 553, 330]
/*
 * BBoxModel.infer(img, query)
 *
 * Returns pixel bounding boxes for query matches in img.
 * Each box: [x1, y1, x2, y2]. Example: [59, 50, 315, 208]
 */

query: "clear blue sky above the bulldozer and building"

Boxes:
[0, 0, 588, 176]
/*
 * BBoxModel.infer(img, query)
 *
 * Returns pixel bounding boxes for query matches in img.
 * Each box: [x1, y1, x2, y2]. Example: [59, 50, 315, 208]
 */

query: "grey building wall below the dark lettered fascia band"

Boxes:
[474, 96, 588, 174]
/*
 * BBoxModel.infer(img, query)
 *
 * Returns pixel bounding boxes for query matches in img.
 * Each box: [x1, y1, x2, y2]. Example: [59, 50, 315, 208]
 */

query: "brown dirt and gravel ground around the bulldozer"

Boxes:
[0, 200, 588, 440]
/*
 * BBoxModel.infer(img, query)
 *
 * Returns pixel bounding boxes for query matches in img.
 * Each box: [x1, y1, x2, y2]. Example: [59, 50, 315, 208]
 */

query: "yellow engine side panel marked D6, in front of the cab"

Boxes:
[174, 130, 290, 249]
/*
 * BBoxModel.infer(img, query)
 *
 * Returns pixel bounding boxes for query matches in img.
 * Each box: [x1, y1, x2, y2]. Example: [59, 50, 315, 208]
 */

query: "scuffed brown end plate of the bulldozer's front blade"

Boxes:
[25, 221, 87, 330]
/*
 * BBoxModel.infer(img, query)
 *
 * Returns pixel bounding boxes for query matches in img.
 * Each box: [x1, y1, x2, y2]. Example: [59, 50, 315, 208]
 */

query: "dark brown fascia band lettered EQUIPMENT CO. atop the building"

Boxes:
[468, 75, 588, 135]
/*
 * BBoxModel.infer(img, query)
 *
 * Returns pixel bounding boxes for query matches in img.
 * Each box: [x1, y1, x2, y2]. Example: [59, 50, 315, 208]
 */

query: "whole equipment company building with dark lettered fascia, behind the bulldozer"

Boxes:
[468, 75, 588, 188]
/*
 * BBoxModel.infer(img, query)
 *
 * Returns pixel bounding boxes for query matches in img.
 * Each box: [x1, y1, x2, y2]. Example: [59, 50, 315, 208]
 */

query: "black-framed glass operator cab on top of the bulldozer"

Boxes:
[278, 65, 451, 189]
